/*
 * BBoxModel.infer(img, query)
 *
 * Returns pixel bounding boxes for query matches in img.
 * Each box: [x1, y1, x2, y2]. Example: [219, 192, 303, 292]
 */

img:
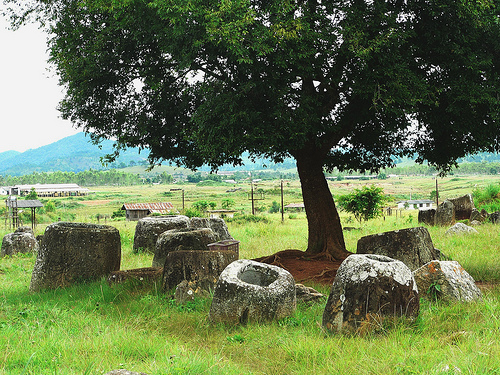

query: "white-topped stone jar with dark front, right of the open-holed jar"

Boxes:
[323, 254, 420, 333]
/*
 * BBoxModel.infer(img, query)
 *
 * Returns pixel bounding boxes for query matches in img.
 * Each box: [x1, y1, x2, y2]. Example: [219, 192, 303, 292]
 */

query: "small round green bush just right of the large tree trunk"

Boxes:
[337, 185, 387, 223]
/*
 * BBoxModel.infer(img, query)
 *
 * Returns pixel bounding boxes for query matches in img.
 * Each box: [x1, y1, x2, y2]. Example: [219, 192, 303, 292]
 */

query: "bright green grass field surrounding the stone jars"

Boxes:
[0, 177, 500, 375]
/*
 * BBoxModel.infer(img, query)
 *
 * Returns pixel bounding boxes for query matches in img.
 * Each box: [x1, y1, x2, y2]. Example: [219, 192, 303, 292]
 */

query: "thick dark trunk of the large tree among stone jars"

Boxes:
[294, 151, 350, 260]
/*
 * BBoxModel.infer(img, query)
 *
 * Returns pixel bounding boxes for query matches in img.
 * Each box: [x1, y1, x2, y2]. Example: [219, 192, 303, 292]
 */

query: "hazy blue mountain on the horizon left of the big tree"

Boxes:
[0, 133, 147, 176]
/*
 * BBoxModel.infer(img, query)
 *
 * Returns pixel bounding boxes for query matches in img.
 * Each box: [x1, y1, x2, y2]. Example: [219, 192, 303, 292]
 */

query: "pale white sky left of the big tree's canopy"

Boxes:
[0, 14, 81, 152]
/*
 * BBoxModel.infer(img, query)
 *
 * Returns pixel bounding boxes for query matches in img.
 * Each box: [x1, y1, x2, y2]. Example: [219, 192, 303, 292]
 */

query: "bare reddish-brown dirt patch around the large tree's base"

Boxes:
[254, 250, 342, 285]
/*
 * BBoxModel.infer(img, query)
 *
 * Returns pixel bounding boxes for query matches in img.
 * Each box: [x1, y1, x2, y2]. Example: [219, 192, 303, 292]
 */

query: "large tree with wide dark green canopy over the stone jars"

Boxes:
[6, 0, 500, 259]
